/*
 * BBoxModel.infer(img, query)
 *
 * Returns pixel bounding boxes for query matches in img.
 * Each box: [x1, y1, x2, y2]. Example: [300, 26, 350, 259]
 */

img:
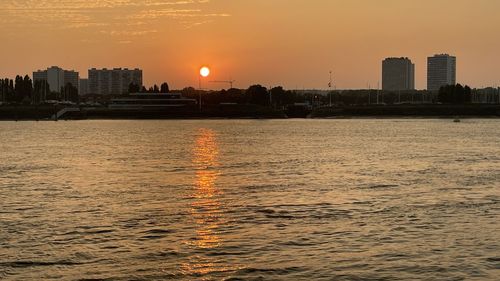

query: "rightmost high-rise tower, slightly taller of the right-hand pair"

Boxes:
[427, 54, 457, 91]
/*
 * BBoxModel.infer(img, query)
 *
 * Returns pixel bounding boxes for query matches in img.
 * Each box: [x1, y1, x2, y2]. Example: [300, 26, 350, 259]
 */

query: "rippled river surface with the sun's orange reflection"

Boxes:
[0, 120, 500, 280]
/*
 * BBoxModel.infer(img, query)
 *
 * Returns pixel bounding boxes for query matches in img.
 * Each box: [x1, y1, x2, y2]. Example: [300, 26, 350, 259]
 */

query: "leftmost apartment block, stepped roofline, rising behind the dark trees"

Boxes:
[33, 66, 79, 92]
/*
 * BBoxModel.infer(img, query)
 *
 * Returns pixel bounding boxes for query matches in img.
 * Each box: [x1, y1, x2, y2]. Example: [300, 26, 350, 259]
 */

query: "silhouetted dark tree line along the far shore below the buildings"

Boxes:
[0, 75, 472, 108]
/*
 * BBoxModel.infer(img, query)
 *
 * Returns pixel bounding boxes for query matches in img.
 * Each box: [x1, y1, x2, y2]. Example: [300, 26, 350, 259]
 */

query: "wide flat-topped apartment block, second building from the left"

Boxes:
[88, 68, 142, 95]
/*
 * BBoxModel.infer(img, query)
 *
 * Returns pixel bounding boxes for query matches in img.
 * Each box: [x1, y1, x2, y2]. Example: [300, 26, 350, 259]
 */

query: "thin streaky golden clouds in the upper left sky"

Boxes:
[0, 0, 229, 36]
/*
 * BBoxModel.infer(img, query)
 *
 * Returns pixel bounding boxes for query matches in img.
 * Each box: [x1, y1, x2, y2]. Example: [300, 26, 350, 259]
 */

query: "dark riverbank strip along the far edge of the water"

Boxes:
[0, 104, 500, 121]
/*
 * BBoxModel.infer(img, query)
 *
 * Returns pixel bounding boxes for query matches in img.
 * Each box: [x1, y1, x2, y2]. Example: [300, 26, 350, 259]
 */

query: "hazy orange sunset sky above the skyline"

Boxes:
[0, 0, 500, 89]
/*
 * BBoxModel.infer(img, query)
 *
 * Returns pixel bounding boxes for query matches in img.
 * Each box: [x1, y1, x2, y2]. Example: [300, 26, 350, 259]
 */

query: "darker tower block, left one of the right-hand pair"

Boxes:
[382, 58, 415, 91]
